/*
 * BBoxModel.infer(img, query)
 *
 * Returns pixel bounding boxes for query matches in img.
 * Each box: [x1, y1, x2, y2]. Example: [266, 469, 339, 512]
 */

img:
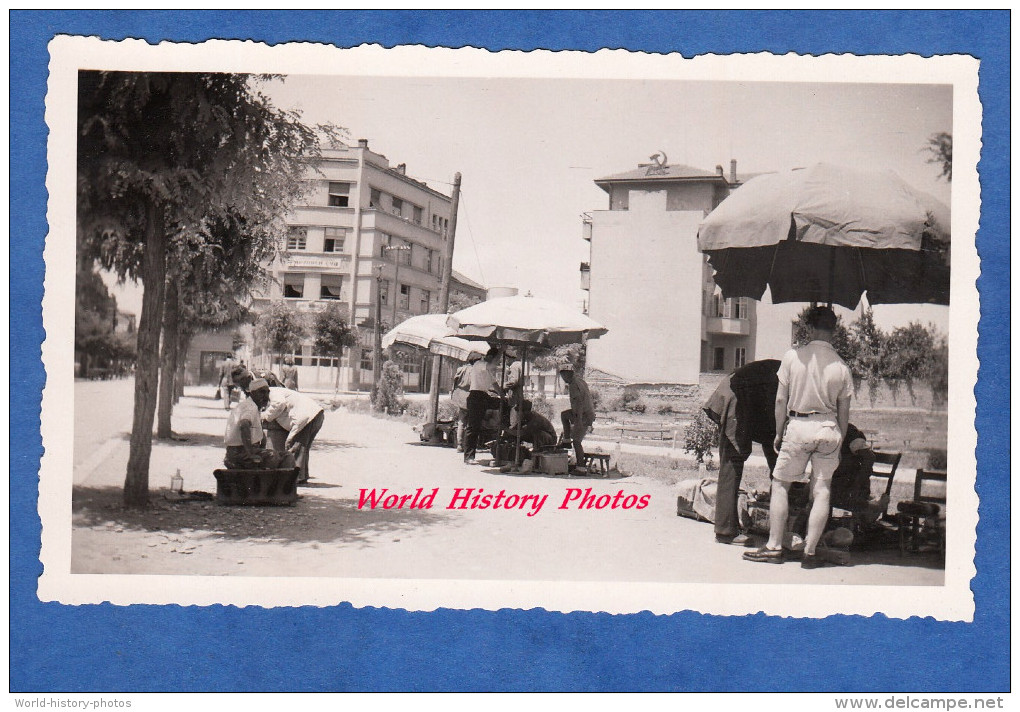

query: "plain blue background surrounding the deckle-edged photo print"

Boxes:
[10, 11, 1010, 692]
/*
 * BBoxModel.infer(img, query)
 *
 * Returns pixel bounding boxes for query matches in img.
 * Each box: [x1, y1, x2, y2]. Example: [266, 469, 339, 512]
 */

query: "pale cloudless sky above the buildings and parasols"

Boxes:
[107, 75, 953, 332]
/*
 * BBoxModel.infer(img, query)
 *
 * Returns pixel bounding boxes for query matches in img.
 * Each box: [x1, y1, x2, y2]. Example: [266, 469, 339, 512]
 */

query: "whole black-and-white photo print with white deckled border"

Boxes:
[39, 38, 980, 620]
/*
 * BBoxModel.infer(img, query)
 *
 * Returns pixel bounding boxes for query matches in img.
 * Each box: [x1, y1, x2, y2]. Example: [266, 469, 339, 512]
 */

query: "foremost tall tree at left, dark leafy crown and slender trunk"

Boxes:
[77, 71, 326, 507]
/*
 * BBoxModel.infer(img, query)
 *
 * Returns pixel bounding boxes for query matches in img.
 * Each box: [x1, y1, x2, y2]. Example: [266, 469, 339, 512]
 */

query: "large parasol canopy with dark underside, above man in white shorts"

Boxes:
[698, 163, 950, 309]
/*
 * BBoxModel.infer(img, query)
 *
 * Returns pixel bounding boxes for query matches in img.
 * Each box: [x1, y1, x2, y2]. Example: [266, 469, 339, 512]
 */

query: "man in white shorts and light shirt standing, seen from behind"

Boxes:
[744, 307, 853, 568]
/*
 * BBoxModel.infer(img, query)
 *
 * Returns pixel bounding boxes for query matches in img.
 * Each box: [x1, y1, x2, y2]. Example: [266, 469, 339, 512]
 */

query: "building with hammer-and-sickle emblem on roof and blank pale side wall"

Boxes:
[580, 159, 757, 384]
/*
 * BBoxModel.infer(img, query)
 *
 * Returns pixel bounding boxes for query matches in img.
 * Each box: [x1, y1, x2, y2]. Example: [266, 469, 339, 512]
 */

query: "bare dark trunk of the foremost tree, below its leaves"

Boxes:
[123, 205, 166, 508]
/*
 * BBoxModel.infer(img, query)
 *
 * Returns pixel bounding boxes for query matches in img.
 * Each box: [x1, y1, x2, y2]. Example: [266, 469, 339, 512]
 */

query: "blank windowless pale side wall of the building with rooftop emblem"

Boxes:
[589, 199, 705, 384]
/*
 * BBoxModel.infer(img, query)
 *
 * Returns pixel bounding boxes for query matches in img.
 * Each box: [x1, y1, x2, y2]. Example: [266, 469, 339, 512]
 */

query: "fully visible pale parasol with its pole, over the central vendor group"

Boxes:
[447, 296, 609, 465]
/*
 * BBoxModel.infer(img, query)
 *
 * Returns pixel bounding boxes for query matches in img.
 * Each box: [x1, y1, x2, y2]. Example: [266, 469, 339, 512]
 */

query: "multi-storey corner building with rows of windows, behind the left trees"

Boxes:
[253, 139, 485, 390]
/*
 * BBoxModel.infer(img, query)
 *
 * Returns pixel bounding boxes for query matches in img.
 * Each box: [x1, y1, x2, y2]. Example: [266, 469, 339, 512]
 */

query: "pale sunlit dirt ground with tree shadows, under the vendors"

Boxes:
[71, 382, 945, 586]
